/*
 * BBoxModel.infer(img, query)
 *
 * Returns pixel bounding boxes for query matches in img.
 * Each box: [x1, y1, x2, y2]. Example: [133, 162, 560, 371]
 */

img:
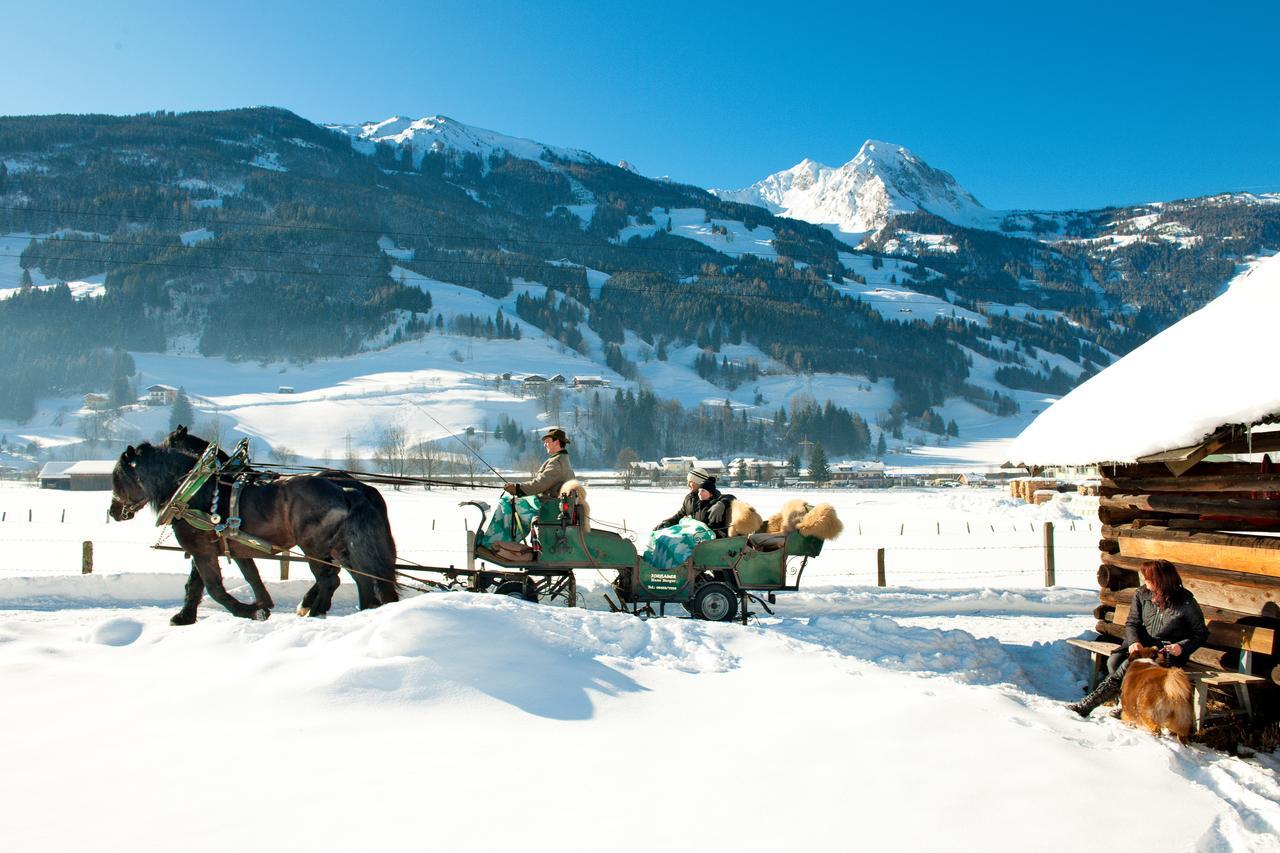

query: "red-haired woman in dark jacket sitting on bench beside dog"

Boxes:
[1068, 560, 1208, 717]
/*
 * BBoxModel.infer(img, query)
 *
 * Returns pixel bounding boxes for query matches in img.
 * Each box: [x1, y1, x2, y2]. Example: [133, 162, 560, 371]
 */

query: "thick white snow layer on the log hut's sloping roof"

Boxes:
[1009, 255, 1280, 465]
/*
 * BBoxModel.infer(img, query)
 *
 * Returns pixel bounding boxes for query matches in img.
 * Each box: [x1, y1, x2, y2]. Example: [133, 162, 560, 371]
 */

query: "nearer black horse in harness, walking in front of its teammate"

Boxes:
[110, 443, 399, 625]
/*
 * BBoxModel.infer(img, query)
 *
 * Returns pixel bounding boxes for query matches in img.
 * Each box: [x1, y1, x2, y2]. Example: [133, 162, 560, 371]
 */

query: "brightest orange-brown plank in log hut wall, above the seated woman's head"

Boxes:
[1102, 528, 1280, 578]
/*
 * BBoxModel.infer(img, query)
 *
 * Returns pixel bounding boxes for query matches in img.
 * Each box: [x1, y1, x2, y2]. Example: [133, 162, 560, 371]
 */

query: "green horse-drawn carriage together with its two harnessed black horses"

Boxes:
[111, 429, 823, 624]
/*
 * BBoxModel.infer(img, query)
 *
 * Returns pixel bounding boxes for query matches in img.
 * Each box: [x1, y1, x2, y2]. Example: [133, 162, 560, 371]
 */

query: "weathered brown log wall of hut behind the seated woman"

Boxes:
[1094, 462, 1280, 684]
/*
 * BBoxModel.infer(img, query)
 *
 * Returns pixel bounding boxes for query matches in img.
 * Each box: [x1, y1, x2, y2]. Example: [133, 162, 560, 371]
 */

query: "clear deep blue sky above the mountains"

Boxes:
[0, 0, 1280, 207]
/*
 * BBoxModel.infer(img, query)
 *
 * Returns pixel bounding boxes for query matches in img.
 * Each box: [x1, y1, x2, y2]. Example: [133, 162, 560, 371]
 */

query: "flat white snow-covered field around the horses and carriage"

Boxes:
[0, 487, 1280, 850]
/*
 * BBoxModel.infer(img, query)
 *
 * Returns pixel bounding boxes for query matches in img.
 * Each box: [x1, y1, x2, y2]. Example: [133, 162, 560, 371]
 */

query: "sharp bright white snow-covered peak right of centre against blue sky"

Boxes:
[712, 140, 993, 234]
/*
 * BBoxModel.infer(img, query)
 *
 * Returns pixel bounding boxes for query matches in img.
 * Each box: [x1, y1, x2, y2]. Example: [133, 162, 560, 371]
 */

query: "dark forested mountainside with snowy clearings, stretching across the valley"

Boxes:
[0, 109, 1280, 448]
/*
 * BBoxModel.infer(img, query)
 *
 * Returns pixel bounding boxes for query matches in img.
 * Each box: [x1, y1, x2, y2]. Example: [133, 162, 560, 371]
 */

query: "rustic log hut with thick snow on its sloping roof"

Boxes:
[1010, 256, 1280, 711]
